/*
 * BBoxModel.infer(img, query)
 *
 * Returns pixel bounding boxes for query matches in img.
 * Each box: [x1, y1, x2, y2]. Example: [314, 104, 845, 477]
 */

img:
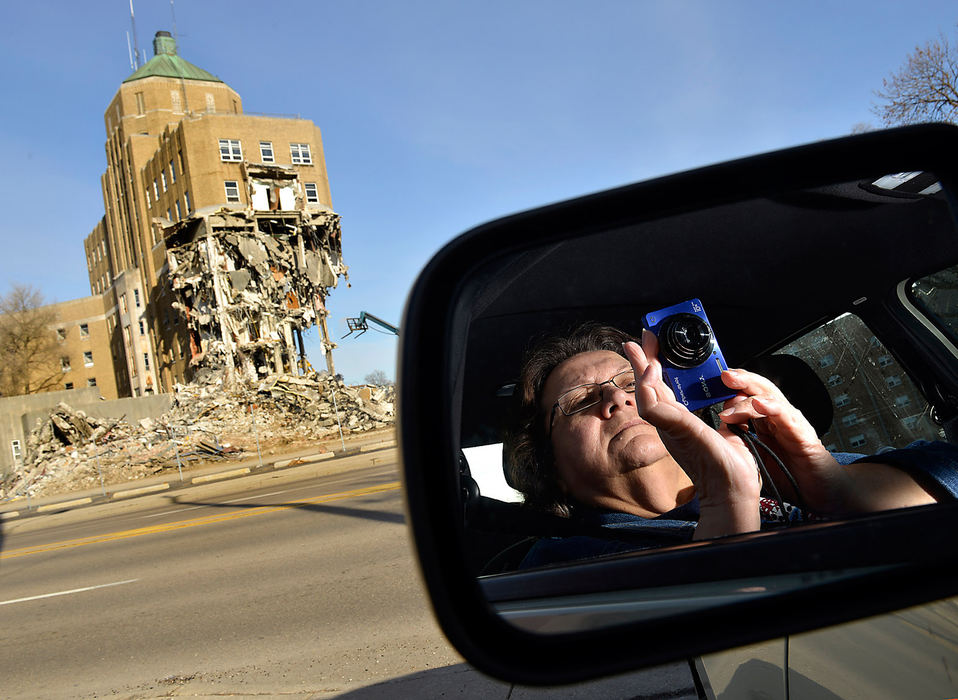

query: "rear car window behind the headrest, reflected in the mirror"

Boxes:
[779, 314, 944, 454]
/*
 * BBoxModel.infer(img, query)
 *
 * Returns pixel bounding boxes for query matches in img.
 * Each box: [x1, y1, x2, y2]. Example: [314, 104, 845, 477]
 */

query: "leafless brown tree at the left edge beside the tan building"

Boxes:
[0, 284, 62, 396]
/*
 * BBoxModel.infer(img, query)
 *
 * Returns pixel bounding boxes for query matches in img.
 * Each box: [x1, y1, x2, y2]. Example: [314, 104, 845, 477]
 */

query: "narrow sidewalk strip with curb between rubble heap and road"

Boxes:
[0, 428, 396, 523]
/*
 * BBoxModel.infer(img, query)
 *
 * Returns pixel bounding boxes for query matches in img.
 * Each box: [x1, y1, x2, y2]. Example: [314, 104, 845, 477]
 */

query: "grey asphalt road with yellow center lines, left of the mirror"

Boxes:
[0, 451, 484, 698]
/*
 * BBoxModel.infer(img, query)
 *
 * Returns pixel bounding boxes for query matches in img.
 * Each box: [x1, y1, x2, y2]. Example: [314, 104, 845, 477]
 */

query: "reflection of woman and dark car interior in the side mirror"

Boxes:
[457, 173, 958, 627]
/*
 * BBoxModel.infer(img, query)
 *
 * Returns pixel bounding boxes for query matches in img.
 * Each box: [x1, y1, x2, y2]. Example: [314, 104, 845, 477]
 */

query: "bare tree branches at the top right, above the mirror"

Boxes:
[872, 28, 958, 126]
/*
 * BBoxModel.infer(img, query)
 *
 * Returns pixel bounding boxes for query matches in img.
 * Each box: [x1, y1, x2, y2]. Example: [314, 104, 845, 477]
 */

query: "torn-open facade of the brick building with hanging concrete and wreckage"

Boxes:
[164, 189, 349, 381]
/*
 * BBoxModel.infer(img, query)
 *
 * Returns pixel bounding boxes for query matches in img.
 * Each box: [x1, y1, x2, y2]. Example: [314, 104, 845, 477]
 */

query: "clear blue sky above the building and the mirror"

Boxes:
[0, 0, 958, 382]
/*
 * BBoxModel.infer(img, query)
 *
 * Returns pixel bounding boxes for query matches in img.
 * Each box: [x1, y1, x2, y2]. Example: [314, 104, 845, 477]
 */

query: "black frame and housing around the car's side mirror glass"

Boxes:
[398, 124, 958, 684]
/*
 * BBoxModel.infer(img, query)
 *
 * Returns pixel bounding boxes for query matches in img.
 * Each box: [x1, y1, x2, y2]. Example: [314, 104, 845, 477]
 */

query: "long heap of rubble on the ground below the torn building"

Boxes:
[0, 370, 395, 498]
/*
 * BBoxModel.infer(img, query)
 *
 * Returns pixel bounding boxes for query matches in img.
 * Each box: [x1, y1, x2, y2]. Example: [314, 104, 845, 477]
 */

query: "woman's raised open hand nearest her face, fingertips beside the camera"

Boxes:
[624, 331, 761, 539]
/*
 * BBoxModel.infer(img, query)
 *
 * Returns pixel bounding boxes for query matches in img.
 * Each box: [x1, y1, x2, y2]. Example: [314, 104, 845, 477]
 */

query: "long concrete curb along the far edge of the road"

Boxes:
[0, 439, 397, 522]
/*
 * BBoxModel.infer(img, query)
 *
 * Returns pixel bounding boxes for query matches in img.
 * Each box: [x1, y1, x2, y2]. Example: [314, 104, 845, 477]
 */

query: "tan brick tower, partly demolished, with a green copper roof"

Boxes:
[72, 31, 346, 398]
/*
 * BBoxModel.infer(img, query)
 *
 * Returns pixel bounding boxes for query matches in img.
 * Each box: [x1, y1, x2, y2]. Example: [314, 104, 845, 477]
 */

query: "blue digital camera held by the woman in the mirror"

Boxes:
[645, 299, 735, 411]
